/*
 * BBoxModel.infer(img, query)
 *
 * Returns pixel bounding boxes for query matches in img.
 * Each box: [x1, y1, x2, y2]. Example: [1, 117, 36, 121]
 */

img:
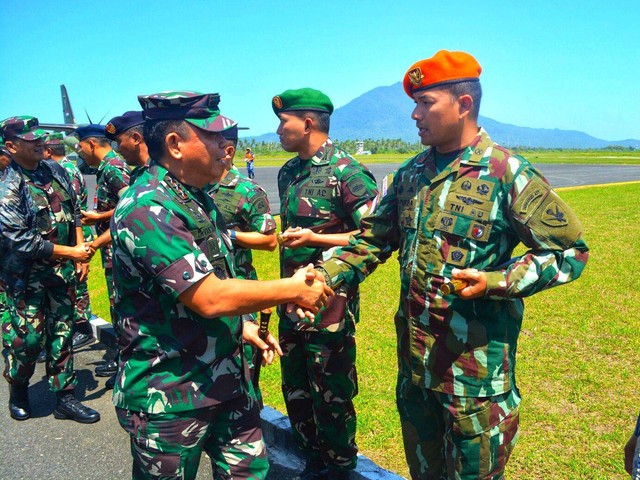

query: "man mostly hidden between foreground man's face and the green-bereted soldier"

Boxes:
[206, 126, 278, 405]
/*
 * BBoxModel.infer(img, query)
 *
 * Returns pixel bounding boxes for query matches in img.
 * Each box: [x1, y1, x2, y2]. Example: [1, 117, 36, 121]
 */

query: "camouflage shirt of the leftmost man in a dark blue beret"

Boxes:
[93, 150, 129, 268]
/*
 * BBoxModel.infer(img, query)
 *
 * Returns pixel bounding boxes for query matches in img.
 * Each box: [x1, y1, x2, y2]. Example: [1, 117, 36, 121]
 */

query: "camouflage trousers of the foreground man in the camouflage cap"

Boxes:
[116, 393, 269, 480]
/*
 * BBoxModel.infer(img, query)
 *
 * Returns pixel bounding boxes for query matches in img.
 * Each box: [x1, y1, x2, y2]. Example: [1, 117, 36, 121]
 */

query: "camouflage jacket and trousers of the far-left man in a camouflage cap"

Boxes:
[0, 160, 80, 392]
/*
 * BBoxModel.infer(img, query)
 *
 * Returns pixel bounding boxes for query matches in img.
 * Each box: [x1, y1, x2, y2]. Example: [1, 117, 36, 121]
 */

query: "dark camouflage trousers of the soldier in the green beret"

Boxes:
[279, 323, 358, 470]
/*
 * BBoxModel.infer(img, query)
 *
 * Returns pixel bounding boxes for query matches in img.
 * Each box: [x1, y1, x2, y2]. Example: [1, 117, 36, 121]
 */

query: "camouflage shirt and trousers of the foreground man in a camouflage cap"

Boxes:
[111, 160, 268, 478]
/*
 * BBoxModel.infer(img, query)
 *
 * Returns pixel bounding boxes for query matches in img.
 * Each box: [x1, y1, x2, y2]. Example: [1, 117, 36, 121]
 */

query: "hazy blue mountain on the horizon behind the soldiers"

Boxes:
[248, 82, 640, 149]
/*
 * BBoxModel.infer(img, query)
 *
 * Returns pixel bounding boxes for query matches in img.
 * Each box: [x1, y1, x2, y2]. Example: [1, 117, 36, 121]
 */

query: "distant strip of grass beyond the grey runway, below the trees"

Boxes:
[241, 150, 640, 168]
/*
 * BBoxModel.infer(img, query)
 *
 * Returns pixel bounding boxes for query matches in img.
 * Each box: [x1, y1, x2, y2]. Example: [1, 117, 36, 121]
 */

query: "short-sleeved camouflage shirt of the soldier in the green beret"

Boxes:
[278, 139, 378, 331]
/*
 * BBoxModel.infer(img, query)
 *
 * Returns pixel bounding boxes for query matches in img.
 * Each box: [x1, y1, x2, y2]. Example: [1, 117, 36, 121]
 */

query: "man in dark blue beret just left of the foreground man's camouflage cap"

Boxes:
[104, 111, 149, 185]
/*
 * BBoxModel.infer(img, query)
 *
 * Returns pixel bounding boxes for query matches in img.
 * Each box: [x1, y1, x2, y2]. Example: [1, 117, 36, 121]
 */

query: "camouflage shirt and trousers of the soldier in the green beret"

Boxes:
[278, 139, 377, 469]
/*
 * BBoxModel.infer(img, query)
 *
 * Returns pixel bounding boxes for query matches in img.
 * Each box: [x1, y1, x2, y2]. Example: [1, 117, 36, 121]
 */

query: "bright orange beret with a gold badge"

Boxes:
[402, 50, 482, 98]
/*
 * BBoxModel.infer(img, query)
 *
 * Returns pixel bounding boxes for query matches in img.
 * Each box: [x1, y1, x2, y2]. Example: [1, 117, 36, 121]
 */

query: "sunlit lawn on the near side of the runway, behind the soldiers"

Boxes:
[90, 183, 640, 480]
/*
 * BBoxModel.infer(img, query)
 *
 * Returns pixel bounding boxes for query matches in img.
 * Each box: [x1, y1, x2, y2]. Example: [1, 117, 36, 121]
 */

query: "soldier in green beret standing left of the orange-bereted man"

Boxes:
[272, 88, 377, 479]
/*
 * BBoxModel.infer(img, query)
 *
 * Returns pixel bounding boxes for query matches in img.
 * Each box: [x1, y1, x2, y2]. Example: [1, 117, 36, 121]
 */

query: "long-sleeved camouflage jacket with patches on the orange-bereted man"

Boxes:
[322, 130, 588, 397]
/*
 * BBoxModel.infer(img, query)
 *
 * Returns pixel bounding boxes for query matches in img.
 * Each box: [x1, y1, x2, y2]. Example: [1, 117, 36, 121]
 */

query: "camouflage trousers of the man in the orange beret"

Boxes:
[396, 375, 520, 480]
